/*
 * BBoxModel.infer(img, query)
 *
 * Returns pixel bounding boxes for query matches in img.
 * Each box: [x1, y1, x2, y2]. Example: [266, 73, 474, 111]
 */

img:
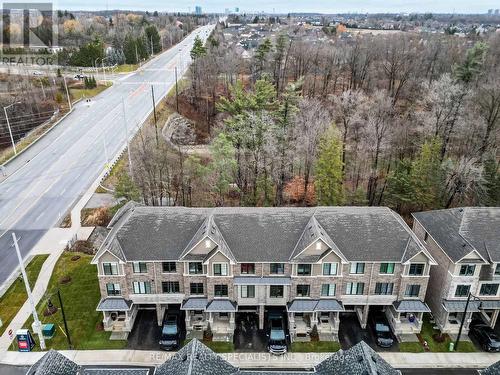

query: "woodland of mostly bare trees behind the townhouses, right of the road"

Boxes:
[122, 25, 500, 214]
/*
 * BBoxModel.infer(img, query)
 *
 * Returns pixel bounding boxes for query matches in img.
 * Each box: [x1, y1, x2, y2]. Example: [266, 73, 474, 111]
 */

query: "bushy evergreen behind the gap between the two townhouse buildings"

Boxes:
[411, 137, 444, 209]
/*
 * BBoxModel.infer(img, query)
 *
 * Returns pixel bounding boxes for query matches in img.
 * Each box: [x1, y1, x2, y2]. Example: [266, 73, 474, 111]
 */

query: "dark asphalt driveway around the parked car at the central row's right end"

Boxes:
[339, 313, 399, 352]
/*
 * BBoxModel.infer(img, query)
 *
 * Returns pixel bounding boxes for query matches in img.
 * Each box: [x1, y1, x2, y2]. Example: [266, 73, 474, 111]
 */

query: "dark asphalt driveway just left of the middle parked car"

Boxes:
[233, 312, 267, 352]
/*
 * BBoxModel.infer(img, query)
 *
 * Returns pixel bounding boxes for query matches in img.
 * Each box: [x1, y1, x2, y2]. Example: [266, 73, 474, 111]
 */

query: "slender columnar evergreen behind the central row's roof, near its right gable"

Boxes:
[315, 125, 344, 206]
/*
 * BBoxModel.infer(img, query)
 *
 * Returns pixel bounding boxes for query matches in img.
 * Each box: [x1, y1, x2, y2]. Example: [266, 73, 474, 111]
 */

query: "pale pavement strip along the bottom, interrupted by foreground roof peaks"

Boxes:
[0, 350, 500, 369]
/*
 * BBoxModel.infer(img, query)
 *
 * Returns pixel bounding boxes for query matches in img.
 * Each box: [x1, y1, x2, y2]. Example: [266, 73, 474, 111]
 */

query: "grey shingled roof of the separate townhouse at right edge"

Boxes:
[412, 207, 500, 263]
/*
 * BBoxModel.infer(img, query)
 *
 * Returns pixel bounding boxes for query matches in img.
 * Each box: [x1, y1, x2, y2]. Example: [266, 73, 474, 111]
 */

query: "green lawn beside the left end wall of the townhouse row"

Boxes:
[16, 252, 127, 350]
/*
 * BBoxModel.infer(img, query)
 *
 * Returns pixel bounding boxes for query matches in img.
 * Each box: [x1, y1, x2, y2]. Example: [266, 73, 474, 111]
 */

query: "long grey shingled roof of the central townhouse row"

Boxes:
[98, 205, 426, 262]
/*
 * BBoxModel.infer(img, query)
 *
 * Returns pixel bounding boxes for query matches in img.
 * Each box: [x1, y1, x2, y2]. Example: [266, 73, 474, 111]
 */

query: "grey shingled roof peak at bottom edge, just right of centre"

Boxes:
[314, 341, 401, 375]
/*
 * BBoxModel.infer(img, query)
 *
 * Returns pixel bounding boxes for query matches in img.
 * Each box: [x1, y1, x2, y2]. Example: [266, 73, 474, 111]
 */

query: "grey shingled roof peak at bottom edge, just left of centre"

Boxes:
[155, 339, 238, 375]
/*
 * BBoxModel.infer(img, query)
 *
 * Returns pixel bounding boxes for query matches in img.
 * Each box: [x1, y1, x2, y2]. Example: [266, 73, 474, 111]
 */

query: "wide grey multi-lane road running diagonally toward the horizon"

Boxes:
[0, 25, 213, 284]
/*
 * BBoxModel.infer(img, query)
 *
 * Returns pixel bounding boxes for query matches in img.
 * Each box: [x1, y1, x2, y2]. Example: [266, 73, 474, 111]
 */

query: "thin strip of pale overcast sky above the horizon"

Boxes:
[45, 0, 500, 13]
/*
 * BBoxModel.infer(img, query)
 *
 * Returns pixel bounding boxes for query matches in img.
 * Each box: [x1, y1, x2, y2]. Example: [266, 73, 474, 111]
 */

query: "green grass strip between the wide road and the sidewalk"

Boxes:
[0, 254, 49, 335]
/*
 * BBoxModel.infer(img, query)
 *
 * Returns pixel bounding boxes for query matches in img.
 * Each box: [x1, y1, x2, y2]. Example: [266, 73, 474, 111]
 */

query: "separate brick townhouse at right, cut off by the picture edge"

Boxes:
[413, 207, 500, 334]
